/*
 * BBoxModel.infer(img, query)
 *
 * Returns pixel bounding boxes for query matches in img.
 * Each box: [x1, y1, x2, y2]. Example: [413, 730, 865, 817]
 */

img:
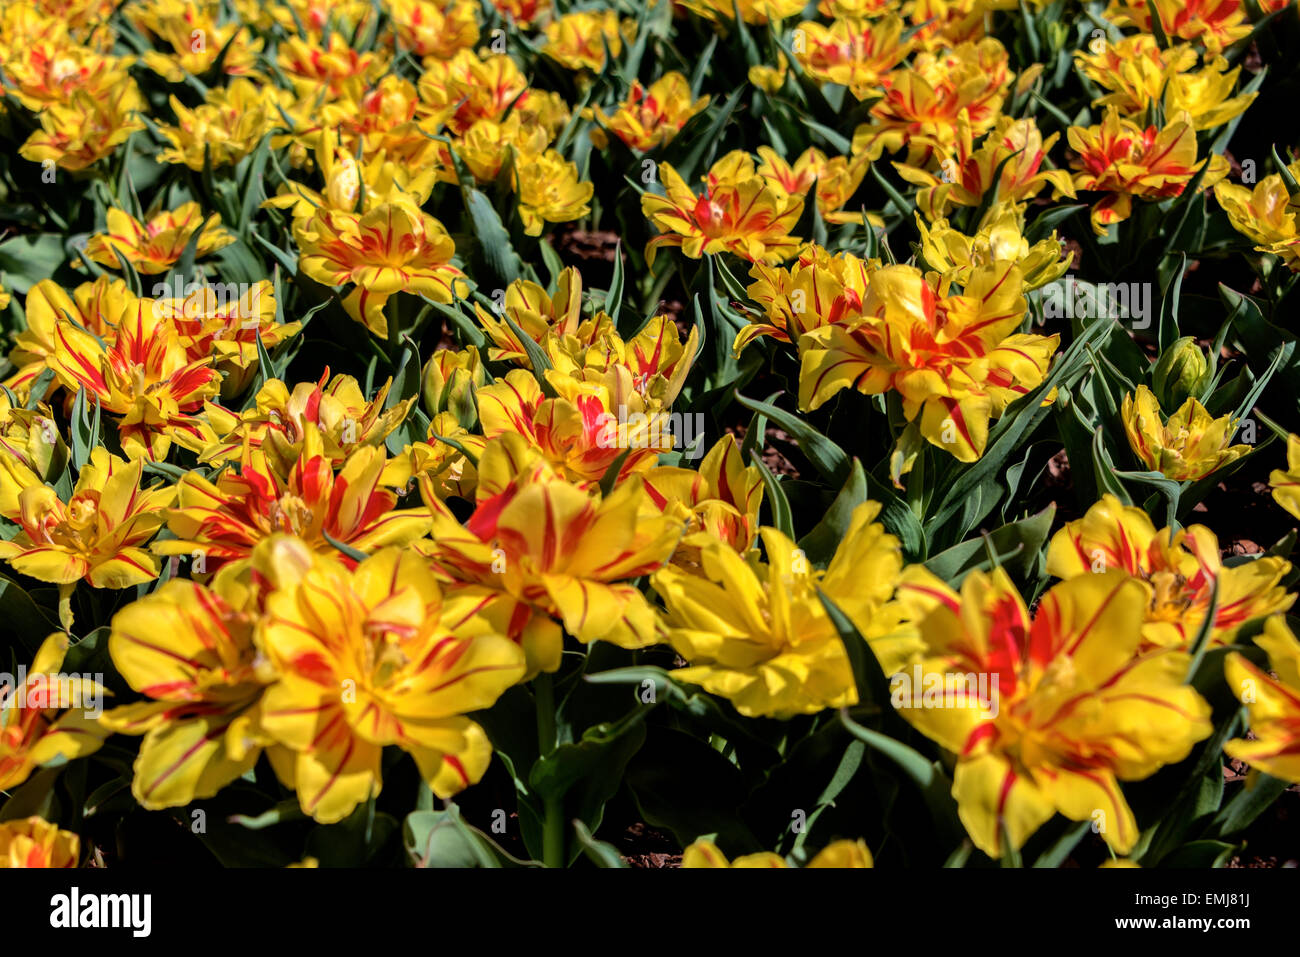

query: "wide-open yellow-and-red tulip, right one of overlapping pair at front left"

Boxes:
[255, 536, 524, 823]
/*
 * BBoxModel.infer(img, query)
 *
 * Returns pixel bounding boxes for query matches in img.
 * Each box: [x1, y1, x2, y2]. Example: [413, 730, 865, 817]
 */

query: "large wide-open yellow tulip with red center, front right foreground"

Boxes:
[892, 568, 1212, 857]
